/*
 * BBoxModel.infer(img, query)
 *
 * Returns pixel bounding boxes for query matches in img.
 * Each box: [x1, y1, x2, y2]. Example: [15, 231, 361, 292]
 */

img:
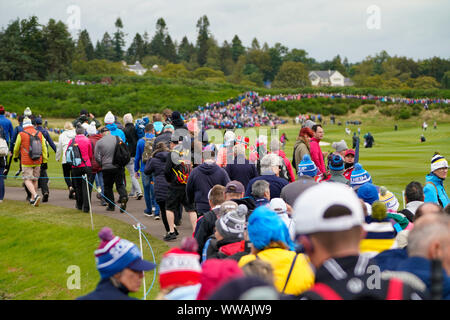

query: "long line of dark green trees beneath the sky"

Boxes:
[0, 15, 450, 89]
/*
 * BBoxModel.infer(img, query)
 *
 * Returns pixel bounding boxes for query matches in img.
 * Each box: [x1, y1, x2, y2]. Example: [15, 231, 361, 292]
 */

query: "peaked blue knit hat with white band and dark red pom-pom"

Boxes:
[95, 227, 156, 279]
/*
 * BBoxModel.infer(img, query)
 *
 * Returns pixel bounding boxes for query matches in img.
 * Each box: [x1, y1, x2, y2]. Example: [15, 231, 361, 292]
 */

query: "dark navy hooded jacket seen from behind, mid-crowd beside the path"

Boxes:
[186, 162, 230, 213]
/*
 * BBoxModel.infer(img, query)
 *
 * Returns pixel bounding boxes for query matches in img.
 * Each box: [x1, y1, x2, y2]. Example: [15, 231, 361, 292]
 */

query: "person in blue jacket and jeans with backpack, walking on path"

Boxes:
[134, 123, 161, 220]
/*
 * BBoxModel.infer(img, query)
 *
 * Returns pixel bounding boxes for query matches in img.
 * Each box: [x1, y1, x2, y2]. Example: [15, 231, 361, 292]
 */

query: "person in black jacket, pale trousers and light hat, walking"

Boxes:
[123, 113, 143, 200]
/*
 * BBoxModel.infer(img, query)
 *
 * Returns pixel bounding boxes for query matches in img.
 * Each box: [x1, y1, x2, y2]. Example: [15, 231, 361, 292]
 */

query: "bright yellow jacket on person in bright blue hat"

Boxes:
[239, 248, 314, 295]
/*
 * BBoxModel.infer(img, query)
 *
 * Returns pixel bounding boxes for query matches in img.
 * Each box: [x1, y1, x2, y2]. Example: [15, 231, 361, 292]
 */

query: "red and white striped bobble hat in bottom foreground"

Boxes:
[159, 237, 202, 289]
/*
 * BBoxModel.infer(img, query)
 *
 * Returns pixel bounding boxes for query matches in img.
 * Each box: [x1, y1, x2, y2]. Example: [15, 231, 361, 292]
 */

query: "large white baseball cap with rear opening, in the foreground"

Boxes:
[294, 182, 364, 234]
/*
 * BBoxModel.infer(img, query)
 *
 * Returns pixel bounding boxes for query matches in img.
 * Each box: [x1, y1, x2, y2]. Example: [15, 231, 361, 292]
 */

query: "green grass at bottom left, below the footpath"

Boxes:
[0, 200, 169, 300]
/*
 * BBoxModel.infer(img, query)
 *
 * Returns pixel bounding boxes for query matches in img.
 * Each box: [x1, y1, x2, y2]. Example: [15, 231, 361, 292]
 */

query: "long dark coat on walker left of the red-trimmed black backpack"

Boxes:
[144, 151, 170, 201]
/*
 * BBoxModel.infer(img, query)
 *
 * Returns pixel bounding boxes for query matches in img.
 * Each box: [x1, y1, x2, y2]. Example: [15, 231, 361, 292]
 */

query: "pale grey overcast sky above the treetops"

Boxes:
[0, 0, 450, 62]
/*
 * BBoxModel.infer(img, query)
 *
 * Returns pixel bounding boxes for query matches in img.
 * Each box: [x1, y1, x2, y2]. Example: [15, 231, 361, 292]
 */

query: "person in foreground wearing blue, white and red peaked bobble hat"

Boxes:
[77, 227, 156, 300]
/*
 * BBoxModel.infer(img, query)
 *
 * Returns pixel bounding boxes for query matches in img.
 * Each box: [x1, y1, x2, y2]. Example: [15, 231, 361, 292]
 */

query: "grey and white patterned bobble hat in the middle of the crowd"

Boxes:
[216, 204, 248, 239]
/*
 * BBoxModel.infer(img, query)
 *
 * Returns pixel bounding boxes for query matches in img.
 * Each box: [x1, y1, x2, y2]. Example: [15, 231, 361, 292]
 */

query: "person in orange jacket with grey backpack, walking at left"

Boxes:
[13, 118, 47, 207]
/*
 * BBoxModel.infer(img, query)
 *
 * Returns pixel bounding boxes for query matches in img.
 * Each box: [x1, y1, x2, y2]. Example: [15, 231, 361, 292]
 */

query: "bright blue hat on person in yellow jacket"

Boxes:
[247, 206, 294, 250]
